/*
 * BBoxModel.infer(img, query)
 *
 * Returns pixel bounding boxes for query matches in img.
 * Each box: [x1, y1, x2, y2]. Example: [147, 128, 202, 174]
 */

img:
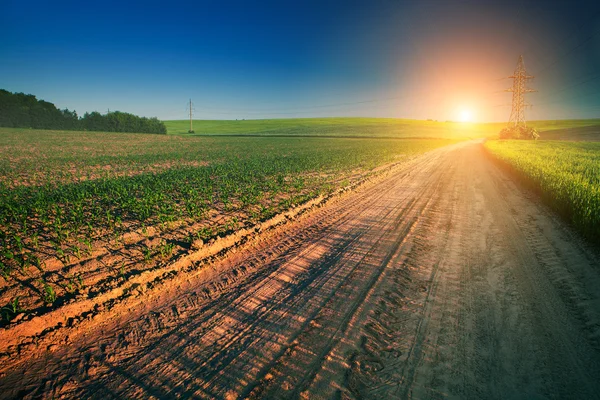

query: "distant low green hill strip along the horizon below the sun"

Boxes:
[165, 118, 600, 140]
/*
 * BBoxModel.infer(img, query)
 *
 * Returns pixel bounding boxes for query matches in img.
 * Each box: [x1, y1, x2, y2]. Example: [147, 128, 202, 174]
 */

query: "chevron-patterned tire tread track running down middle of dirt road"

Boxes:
[346, 158, 460, 398]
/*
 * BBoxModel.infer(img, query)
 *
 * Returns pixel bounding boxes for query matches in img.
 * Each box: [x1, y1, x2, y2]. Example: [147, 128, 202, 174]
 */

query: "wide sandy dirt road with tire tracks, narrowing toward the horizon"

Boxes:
[0, 142, 600, 399]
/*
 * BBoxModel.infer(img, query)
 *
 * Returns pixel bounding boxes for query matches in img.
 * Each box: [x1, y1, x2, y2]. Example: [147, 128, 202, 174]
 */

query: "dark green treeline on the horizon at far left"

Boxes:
[0, 89, 167, 134]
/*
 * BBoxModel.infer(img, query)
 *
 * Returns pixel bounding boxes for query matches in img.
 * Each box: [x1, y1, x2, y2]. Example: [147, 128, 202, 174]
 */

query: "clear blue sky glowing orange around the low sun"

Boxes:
[0, 0, 600, 121]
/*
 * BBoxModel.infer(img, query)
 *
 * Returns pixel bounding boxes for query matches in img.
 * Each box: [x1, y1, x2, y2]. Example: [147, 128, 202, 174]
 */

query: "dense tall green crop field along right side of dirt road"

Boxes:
[485, 140, 600, 240]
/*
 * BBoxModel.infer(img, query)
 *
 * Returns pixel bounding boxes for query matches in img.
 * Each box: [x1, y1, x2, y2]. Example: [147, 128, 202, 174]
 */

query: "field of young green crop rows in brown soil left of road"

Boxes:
[0, 128, 453, 322]
